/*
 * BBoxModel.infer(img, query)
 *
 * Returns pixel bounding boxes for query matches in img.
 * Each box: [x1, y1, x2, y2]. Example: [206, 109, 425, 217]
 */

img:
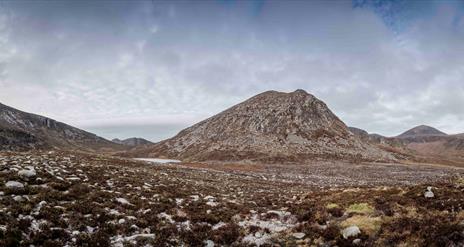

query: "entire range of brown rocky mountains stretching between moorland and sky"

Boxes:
[0, 90, 464, 164]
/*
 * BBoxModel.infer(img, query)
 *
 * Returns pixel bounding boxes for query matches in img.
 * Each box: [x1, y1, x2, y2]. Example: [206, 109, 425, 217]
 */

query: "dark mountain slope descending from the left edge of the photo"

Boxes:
[0, 104, 122, 151]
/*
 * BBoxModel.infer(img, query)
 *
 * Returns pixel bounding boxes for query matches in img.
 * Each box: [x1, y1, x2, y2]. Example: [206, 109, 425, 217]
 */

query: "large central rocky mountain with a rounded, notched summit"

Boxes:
[126, 90, 393, 162]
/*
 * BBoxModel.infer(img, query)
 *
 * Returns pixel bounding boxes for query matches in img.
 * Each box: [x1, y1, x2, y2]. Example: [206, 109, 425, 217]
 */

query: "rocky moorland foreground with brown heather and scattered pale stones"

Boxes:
[0, 152, 464, 246]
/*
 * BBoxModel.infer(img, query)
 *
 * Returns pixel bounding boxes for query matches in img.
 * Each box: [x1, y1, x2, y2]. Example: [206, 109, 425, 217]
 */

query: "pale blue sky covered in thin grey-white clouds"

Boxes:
[0, 0, 464, 141]
